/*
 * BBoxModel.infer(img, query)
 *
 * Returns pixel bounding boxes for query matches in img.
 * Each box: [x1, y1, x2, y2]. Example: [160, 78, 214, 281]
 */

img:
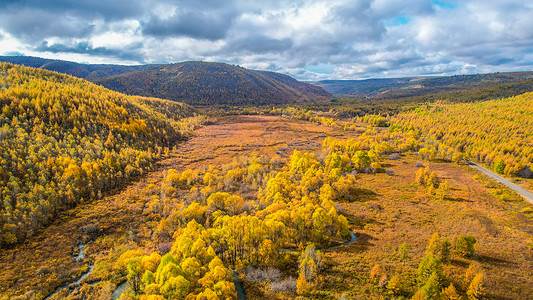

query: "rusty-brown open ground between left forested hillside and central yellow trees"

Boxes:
[0, 116, 350, 299]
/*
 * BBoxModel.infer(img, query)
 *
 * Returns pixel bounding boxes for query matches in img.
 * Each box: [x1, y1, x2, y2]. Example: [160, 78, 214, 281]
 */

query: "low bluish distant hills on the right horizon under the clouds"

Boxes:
[313, 72, 533, 99]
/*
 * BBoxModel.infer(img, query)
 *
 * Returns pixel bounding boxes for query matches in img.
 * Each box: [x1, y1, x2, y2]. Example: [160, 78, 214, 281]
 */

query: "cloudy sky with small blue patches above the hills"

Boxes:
[0, 0, 533, 80]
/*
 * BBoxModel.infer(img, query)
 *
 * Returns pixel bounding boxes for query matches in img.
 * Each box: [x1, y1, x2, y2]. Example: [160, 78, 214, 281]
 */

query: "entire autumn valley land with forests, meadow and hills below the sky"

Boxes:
[0, 58, 533, 300]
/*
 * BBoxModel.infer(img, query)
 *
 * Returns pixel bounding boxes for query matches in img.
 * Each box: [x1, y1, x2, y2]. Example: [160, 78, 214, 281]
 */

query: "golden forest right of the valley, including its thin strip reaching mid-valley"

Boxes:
[274, 92, 533, 178]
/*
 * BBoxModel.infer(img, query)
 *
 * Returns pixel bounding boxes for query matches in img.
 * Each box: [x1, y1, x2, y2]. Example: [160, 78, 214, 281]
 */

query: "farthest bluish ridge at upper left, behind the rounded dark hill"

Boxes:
[0, 56, 154, 80]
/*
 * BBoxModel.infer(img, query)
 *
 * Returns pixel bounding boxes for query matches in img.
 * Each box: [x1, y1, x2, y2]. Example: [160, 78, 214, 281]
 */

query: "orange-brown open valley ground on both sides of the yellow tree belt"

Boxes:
[0, 116, 533, 299]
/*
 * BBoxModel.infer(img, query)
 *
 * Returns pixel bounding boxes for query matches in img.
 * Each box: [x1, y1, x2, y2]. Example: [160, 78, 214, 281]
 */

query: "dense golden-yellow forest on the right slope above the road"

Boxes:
[391, 93, 533, 178]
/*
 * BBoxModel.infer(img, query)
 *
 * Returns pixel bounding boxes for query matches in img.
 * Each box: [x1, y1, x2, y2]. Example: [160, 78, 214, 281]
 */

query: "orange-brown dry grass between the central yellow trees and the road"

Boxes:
[317, 156, 533, 299]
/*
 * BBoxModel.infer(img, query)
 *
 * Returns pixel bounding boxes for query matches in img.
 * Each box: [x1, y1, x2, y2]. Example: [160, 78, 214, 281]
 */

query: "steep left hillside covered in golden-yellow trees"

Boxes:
[0, 63, 201, 246]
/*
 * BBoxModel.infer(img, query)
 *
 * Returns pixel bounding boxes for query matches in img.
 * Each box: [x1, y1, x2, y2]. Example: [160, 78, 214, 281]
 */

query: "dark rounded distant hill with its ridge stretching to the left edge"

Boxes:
[0, 56, 331, 106]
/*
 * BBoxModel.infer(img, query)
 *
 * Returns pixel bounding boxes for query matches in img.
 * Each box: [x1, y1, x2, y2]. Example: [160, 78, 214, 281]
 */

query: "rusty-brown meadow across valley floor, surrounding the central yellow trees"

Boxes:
[0, 115, 533, 299]
